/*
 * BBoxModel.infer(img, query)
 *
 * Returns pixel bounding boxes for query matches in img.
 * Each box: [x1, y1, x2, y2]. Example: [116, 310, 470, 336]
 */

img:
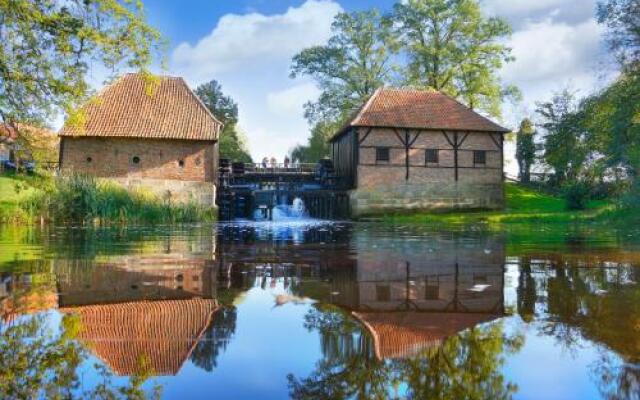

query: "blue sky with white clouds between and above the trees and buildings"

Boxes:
[82, 0, 614, 173]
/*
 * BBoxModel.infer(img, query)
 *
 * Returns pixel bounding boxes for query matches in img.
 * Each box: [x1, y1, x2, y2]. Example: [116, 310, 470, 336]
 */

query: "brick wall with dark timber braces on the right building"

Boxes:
[350, 128, 504, 216]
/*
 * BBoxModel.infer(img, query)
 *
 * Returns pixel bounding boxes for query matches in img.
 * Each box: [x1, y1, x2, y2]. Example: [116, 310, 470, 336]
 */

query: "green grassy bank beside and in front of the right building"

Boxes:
[384, 183, 638, 225]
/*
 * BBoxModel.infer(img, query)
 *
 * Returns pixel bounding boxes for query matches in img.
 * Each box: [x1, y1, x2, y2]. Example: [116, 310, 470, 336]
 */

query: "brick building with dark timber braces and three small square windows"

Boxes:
[330, 88, 509, 216]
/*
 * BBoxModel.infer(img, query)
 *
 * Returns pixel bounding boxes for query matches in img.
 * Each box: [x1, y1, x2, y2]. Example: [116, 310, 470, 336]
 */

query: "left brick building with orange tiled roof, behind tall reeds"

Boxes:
[60, 74, 222, 206]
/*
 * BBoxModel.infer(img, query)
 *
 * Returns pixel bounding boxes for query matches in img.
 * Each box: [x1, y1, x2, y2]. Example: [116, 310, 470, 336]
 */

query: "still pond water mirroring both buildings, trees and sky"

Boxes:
[0, 220, 640, 400]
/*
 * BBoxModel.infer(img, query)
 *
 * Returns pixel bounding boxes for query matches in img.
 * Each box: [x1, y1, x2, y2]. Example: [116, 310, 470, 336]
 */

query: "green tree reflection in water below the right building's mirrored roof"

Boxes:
[288, 306, 523, 399]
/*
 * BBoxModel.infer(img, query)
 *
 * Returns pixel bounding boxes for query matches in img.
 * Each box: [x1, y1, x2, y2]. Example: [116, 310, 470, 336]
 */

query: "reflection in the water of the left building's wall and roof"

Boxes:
[57, 249, 218, 375]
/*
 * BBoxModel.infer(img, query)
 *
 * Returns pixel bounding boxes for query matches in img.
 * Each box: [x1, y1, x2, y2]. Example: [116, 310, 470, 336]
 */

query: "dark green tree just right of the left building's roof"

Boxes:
[195, 79, 251, 162]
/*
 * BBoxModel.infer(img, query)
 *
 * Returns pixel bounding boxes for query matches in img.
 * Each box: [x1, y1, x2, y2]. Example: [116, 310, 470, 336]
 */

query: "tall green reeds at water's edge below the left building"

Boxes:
[20, 175, 215, 225]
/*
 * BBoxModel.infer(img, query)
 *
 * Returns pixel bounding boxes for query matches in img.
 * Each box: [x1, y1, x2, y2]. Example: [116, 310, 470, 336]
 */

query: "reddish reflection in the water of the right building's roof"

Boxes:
[353, 311, 499, 360]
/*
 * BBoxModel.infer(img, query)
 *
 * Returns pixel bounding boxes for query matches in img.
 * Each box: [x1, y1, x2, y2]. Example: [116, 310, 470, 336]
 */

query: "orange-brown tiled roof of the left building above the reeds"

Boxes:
[60, 74, 222, 140]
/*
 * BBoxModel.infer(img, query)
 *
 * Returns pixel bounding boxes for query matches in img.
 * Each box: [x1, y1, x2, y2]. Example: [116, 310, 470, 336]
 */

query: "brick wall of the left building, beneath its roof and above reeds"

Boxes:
[61, 137, 217, 207]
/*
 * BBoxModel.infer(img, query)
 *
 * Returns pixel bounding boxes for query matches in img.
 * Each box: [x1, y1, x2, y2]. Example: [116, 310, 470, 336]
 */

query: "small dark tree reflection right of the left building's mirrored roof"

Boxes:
[191, 306, 238, 372]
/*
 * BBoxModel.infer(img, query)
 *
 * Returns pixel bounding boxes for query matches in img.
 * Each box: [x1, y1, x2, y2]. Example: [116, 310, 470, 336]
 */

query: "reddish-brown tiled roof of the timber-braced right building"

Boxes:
[334, 88, 509, 138]
